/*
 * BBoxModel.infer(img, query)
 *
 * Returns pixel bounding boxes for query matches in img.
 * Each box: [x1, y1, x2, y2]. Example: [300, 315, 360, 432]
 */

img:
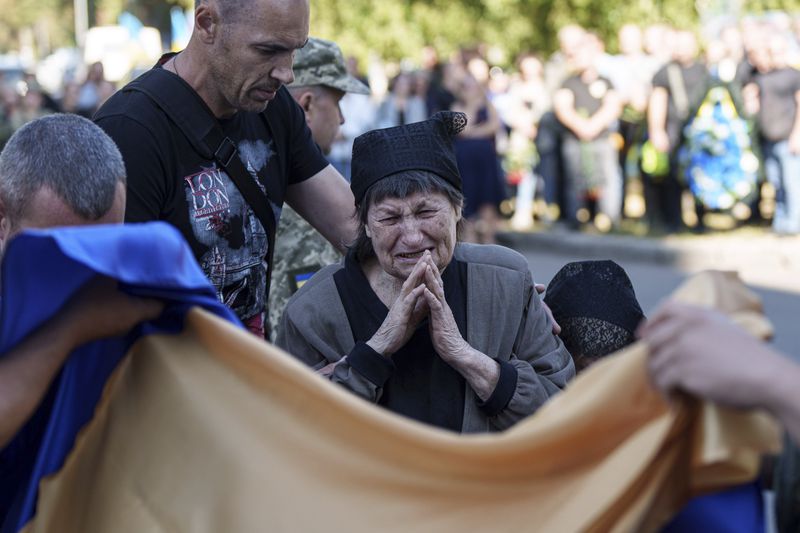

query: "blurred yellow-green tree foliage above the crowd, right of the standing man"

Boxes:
[311, 0, 708, 65]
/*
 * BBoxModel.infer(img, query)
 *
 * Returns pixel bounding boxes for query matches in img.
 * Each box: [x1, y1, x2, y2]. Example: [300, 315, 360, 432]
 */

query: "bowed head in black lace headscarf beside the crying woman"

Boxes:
[544, 261, 644, 372]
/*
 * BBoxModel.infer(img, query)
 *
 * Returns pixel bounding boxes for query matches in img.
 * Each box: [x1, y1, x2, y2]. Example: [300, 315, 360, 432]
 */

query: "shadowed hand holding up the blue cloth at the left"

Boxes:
[59, 276, 164, 346]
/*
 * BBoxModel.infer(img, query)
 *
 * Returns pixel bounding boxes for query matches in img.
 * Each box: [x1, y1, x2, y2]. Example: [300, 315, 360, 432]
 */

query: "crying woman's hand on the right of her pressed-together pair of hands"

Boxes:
[420, 252, 469, 362]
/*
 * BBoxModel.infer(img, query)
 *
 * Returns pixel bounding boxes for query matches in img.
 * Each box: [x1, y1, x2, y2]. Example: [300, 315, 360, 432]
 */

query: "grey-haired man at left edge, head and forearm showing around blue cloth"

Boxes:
[0, 115, 163, 448]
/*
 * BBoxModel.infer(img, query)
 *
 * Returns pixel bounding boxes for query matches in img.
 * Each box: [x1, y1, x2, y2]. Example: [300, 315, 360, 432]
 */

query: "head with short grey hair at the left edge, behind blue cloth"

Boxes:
[0, 114, 125, 254]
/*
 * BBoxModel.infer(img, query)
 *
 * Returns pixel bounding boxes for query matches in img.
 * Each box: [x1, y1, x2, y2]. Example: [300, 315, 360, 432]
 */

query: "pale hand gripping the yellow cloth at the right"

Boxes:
[637, 302, 782, 408]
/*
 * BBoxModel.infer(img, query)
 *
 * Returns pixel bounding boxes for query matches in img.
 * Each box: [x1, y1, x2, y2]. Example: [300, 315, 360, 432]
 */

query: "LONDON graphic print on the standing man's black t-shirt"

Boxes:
[183, 140, 280, 337]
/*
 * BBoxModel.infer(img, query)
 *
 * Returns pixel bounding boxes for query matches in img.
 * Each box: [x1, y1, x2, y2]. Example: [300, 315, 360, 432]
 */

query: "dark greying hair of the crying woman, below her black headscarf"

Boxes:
[349, 170, 464, 263]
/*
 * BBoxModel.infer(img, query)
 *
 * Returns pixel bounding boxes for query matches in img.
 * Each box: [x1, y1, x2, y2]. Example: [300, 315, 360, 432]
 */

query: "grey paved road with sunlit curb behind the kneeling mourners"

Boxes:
[500, 228, 800, 361]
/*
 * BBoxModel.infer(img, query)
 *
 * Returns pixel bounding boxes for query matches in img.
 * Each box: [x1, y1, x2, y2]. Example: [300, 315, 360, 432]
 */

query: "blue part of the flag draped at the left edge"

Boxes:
[0, 222, 241, 533]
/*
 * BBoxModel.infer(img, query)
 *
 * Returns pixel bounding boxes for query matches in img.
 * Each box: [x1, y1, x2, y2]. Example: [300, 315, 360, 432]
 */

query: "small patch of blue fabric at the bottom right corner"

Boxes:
[662, 483, 765, 533]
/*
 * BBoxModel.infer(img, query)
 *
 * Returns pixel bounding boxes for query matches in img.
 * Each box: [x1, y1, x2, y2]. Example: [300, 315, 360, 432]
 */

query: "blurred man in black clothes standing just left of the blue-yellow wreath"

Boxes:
[644, 31, 710, 232]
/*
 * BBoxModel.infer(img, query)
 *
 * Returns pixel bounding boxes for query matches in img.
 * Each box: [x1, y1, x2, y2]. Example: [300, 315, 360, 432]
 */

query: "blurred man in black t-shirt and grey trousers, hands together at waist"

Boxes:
[553, 34, 622, 229]
